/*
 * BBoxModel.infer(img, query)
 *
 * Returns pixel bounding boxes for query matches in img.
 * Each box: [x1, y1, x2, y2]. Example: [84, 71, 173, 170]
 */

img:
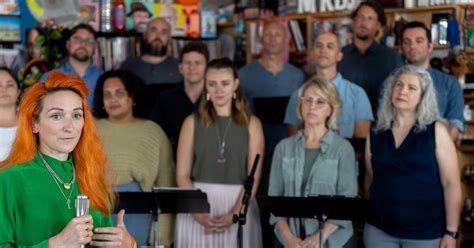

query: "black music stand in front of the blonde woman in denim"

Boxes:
[257, 195, 373, 247]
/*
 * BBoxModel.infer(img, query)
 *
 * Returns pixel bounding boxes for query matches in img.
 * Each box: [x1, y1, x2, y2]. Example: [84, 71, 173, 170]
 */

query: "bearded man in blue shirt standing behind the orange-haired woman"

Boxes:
[40, 23, 102, 106]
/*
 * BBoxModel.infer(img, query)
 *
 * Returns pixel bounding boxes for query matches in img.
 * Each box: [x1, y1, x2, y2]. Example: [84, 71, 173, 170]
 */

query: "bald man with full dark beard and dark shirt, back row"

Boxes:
[121, 18, 183, 85]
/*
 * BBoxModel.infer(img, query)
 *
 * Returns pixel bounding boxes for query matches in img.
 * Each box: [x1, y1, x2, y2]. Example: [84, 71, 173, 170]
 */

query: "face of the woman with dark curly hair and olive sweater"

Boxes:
[103, 77, 133, 121]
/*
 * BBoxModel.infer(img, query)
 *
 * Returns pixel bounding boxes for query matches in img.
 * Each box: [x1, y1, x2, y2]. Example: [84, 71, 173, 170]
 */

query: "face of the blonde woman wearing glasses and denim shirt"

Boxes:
[300, 87, 332, 126]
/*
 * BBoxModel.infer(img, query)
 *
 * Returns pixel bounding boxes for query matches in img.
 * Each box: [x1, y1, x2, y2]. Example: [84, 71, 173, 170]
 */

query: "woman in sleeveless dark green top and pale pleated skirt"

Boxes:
[175, 58, 264, 248]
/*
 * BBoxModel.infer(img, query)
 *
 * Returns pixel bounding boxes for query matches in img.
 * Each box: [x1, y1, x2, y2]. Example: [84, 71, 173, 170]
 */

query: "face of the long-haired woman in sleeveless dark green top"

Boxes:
[206, 68, 239, 107]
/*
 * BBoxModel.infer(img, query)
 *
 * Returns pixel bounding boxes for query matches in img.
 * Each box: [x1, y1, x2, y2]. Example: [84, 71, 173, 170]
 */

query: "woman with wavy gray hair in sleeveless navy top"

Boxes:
[364, 65, 461, 248]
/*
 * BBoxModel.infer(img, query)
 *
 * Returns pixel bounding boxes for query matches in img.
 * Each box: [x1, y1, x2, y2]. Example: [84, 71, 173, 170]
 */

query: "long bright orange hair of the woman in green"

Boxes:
[0, 72, 116, 215]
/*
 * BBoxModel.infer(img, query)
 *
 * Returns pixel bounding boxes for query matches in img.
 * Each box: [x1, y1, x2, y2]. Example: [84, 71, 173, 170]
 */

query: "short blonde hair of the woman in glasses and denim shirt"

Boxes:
[296, 76, 342, 131]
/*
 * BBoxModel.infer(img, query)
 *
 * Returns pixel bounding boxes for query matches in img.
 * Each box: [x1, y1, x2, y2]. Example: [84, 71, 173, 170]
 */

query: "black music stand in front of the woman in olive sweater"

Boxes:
[117, 187, 210, 248]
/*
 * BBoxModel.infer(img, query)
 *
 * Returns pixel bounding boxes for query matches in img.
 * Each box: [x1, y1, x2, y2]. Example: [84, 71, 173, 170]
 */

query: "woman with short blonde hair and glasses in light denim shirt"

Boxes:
[268, 77, 357, 247]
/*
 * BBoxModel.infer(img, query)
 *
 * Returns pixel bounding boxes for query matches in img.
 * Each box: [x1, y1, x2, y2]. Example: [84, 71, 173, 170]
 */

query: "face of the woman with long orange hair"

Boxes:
[33, 90, 84, 160]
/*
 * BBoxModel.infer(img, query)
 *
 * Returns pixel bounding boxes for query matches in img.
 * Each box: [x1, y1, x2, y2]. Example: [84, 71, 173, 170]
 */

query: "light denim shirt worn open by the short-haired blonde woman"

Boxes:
[268, 131, 357, 248]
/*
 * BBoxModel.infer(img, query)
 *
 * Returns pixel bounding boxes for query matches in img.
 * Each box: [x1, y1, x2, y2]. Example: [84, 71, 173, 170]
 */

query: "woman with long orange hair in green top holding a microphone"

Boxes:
[0, 72, 135, 247]
